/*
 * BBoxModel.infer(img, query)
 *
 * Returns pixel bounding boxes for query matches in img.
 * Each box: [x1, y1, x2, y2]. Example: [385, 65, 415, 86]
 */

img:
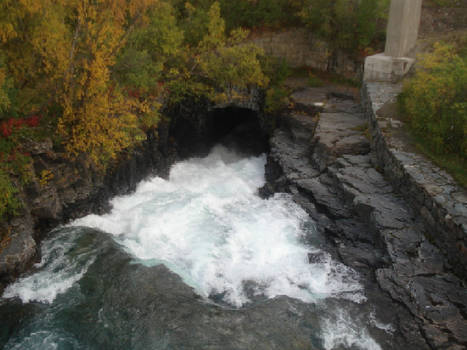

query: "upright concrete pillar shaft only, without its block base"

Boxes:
[384, 0, 422, 57]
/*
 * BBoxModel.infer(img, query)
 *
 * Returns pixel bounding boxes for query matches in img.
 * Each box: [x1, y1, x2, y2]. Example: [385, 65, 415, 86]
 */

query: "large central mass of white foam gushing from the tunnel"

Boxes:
[73, 147, 364, 306]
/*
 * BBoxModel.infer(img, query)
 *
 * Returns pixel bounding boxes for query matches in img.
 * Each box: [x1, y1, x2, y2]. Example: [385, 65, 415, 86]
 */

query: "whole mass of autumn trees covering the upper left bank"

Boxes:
[0, 0, 267, 169]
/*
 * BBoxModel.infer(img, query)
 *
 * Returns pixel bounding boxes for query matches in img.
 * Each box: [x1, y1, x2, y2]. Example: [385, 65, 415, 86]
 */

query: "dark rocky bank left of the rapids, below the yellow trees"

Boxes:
[0, 125, 176, 294]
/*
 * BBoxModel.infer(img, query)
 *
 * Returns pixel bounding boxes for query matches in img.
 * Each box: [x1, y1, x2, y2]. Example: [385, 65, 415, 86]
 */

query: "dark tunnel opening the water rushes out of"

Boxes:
[172, 107, 269, 158]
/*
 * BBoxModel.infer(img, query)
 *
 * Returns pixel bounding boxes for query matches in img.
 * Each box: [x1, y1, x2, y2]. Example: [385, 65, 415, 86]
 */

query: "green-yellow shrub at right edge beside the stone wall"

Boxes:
[400, 43, 467, 160]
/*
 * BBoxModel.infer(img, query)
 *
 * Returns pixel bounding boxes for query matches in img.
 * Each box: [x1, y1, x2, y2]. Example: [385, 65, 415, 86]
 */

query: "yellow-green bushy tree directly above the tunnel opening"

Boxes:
[168, 2, 268, 102]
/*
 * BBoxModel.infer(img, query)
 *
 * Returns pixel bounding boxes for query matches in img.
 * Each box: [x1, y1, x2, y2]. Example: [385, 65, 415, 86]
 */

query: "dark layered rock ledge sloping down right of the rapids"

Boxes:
[260, 89, 467, 349]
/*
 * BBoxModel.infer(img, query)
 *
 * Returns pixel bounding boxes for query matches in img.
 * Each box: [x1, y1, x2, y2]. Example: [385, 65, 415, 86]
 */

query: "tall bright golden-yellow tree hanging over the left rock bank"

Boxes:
[57, 0, 159, 167]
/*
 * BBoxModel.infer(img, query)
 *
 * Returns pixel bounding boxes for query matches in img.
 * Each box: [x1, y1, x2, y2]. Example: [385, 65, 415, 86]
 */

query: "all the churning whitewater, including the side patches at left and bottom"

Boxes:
[2, 146, 386, 350]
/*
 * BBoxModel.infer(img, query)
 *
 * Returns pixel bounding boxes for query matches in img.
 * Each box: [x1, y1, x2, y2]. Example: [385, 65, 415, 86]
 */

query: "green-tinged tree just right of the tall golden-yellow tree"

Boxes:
[112, 2, 184, 130]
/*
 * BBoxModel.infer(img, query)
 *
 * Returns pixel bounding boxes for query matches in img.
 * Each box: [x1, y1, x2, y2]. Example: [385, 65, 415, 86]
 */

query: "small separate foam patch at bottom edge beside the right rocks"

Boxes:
[321, 310, 381, 350]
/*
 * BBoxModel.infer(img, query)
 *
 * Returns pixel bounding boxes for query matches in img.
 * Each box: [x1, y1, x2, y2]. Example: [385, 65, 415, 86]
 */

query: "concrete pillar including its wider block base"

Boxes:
[363, 0, 422, 82]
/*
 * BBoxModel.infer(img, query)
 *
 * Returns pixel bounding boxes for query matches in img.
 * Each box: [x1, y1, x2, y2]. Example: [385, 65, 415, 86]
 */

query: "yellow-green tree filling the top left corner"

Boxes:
[0, 0, 71, 115]
